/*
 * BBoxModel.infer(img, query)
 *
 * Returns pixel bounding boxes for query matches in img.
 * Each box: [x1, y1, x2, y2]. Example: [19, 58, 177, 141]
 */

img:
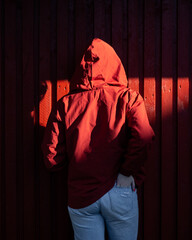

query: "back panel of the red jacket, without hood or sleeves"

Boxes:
[62, 86, 135, 208]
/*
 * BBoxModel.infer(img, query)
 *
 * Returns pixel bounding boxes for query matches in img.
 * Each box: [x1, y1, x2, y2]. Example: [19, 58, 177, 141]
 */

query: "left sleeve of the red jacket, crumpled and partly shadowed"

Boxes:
[42, 104, 67, 171]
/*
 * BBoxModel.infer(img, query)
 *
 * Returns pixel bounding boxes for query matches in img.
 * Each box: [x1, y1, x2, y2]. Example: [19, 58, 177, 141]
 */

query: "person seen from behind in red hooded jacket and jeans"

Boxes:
[42, 38, 154, 240]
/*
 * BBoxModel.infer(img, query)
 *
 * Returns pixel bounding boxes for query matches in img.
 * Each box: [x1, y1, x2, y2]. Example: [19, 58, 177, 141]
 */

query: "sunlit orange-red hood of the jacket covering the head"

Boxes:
[70, 38, 127, 91]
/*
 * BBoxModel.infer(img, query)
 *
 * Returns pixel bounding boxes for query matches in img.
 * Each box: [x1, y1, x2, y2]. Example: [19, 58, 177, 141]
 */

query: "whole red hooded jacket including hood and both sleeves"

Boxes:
[42, 39, 154, 208]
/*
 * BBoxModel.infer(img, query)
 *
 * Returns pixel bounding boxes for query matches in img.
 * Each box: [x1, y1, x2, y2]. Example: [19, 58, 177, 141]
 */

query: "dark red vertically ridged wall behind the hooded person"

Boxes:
[0, 0, 192, 240]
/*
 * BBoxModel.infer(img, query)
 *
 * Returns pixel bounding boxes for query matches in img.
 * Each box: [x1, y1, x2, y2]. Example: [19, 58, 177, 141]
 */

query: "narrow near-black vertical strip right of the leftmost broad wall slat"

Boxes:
[16, 0, 24, 240]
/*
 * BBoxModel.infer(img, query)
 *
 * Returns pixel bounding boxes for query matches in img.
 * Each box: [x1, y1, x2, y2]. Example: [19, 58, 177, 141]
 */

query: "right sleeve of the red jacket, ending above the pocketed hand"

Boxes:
[120, 92, 155, 186]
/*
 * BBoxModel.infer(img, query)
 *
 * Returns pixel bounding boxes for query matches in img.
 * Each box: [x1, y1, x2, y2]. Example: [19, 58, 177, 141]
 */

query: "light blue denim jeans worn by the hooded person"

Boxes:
[68, 185, 138, 240]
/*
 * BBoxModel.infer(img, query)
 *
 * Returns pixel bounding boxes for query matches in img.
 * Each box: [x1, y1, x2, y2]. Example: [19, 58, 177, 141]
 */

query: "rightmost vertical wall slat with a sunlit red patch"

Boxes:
[176, 0, 192, 239]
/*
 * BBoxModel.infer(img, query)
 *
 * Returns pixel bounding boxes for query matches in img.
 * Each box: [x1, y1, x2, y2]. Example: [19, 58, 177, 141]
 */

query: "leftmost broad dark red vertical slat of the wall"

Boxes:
[4, 1, 17, 240]
